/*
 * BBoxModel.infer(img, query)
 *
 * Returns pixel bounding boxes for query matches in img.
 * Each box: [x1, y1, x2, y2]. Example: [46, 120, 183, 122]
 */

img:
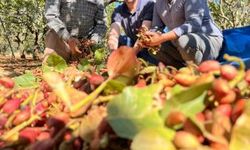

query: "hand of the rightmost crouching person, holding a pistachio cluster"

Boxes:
[143, 31, 164, 47]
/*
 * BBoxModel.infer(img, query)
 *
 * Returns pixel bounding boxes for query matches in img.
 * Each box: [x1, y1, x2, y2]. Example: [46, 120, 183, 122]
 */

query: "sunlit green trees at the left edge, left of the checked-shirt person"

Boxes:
[0, 0, 45, 56]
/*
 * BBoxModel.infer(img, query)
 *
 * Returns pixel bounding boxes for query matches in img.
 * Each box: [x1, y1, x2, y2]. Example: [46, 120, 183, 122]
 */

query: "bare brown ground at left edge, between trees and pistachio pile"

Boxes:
[0, 55, 42, 77]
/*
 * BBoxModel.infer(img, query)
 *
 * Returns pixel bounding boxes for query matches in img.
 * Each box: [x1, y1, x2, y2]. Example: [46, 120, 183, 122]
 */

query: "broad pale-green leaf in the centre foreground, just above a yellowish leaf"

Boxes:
[107, 84, 164, 139]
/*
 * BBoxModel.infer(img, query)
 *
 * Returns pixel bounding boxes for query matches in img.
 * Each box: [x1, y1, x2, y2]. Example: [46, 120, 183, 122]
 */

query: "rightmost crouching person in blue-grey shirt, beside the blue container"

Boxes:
[144, 0, 223, 68]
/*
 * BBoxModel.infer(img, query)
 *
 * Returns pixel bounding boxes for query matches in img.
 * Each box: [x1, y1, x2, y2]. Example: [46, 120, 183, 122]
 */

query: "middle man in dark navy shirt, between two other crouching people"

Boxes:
[108, 0, 156, 63]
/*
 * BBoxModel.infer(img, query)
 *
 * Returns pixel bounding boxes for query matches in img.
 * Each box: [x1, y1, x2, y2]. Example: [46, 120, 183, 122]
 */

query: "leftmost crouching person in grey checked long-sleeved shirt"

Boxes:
[44, 0, 107, 61]
